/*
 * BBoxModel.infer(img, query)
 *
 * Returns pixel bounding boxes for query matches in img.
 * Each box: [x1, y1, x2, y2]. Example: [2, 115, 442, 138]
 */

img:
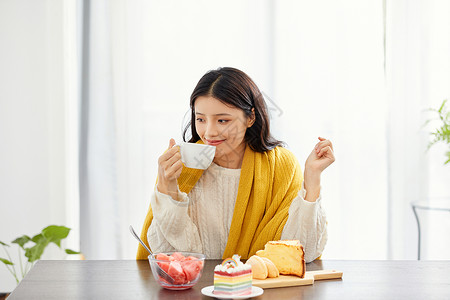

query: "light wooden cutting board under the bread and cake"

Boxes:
[252, 270, 343, 289]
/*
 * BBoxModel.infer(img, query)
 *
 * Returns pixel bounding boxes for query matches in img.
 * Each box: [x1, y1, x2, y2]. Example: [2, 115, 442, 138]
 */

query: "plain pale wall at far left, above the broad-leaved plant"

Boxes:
[0, 0, 66, 292]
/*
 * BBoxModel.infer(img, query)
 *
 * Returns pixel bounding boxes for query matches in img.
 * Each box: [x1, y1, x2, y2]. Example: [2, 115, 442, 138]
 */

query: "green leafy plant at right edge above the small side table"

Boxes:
[426, 100, 450, 164]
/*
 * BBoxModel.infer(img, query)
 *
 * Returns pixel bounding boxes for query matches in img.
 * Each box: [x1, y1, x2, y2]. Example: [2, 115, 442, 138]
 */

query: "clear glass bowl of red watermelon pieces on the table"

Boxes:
[148, 252, 206, 290]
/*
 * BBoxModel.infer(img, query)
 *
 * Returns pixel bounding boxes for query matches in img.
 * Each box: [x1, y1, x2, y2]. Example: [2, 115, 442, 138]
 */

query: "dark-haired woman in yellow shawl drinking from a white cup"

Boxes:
[137, 68, 335, 262]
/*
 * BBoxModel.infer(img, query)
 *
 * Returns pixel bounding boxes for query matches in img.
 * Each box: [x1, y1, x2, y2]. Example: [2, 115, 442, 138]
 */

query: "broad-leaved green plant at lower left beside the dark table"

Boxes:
[0, 225, 80, 299]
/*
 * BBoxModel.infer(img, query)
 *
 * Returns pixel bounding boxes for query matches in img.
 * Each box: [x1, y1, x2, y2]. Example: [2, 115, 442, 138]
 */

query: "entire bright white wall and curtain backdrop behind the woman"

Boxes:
[0, 0, 450, 291]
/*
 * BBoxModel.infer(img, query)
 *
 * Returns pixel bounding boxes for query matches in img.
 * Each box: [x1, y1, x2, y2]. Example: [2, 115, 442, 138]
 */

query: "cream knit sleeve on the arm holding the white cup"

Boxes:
[147, 188, 203, 253]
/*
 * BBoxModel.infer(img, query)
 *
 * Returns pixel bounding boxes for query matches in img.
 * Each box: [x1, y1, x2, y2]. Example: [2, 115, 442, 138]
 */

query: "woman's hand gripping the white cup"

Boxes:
[157, 139, 183, 200]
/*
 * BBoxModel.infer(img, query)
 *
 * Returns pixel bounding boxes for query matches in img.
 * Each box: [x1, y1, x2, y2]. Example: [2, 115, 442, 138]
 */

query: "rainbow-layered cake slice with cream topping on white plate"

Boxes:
[214, 254, 252, 296]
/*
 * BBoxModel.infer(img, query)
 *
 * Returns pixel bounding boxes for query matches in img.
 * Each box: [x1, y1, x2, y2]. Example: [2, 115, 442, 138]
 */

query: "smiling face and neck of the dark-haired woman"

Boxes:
[194, 96, 253, 168]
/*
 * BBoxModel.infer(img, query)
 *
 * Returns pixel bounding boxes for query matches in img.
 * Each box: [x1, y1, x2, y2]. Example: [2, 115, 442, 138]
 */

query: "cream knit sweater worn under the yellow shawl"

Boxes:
[147, 163, 327, 262]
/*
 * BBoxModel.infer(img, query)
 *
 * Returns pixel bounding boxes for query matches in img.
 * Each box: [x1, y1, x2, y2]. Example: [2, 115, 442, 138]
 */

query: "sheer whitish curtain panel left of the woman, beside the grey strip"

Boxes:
[80, 0, 146, 259]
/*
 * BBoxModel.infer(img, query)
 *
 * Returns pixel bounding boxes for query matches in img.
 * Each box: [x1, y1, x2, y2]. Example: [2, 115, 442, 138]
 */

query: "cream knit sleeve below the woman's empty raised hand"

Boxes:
[281, 184, 328, 262]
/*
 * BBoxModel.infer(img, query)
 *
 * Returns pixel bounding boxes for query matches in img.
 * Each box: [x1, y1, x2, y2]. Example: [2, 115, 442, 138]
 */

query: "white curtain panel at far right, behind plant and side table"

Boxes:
[386, 0, 450, 259]
